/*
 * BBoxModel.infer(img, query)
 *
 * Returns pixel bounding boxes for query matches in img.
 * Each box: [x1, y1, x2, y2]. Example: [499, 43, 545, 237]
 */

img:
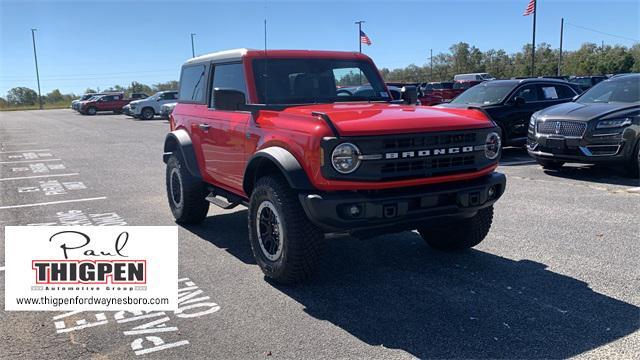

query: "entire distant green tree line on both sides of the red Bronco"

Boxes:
[0, 42, 640, 108]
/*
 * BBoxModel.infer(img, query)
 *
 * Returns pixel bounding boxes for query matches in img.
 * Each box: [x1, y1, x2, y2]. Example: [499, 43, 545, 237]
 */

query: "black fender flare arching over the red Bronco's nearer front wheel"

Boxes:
[242, 146, 314, 195]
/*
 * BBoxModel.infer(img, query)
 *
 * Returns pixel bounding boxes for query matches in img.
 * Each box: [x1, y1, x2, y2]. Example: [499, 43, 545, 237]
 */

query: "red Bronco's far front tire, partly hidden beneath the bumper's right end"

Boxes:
[418, 205, 493, 251]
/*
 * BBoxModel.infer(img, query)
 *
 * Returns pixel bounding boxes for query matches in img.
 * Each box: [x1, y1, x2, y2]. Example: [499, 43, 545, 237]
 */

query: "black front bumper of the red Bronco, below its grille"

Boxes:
[299, 172, 506, 232]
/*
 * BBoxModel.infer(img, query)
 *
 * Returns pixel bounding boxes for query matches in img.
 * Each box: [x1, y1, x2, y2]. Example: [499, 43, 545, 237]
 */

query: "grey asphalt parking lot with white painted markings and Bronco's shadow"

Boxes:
[0, 109, 640, 359]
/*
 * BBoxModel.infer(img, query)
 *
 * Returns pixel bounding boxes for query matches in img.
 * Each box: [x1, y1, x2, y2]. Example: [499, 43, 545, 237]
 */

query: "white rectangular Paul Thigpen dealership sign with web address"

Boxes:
[5, 226, 178, 311]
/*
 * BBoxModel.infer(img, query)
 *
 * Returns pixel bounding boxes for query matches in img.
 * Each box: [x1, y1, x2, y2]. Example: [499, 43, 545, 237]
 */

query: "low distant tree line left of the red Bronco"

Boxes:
[0, 80, 178, 109]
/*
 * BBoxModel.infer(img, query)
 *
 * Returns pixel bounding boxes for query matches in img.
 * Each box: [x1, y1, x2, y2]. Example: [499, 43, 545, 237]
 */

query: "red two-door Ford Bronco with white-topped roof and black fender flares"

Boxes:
[163, 49, 506, 283]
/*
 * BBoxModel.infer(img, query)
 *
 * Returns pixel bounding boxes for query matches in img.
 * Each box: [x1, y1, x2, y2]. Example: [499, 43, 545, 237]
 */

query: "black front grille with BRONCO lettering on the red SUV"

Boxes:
[322, 129, 497, 181]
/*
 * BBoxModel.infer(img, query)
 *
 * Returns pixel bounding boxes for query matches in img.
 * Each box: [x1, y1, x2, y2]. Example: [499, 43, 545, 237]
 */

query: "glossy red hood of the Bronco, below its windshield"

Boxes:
[284, 103, 494, 136]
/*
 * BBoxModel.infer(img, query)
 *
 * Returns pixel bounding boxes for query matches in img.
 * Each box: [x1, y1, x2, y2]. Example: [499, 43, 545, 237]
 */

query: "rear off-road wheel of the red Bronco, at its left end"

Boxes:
[166, 154, 209, 224]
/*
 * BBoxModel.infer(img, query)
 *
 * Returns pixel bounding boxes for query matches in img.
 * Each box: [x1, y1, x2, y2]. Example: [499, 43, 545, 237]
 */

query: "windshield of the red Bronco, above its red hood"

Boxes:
[253, 58, 391, 105]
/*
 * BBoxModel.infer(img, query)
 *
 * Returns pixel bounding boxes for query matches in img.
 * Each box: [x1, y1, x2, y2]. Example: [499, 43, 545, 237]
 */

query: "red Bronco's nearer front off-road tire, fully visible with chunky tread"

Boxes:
[248, 175, 324, 285]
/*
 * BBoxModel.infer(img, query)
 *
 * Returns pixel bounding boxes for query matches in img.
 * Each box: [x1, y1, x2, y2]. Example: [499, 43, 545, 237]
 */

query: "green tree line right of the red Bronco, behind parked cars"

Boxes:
[380, 42, 640, 82]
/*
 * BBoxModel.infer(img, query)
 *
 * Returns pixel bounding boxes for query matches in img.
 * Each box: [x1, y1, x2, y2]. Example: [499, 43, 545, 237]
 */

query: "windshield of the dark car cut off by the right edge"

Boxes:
[576, 76, 640, 104]
